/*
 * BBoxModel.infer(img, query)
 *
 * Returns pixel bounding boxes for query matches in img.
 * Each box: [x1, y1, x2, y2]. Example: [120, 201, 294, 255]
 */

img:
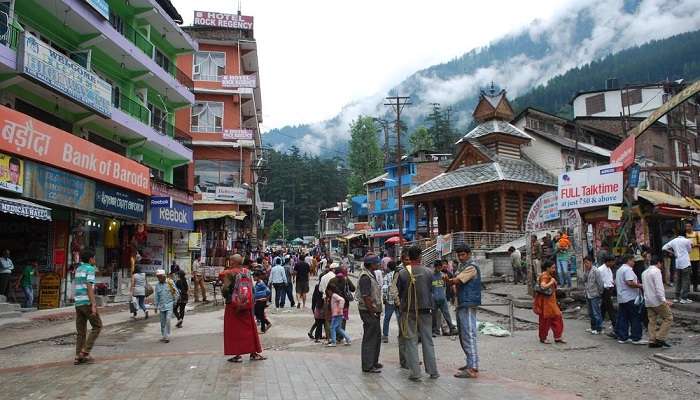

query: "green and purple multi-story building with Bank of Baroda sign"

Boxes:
[0, 0, 197, 306]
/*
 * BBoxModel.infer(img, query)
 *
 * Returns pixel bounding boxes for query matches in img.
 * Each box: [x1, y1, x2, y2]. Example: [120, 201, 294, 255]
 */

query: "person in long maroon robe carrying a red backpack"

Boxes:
[219, 254, 265, 363]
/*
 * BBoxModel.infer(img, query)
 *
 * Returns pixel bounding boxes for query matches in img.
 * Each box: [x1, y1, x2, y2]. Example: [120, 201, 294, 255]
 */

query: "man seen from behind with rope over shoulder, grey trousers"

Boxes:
[396, 246, 440, 381]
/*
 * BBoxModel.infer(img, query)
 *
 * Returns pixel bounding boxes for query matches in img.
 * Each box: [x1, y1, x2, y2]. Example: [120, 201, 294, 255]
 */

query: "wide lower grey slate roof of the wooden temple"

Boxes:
[403, 156, 557, 197]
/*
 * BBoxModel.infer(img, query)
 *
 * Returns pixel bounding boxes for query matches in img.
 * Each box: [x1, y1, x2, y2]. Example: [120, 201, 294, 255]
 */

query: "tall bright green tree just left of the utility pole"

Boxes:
[348, 116, 384, 196]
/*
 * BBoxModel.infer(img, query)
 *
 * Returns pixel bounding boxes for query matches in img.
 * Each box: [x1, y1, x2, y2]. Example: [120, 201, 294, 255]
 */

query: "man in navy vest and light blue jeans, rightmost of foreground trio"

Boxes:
[450, 246, 481, 378]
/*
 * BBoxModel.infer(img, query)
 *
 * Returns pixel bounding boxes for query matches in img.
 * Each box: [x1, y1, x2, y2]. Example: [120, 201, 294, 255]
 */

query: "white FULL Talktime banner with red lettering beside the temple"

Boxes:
[557, 164, 624, 210]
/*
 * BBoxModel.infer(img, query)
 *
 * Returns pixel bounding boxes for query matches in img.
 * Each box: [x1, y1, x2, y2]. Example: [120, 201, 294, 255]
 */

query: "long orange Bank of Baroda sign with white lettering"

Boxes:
[0, 105, 151, 195]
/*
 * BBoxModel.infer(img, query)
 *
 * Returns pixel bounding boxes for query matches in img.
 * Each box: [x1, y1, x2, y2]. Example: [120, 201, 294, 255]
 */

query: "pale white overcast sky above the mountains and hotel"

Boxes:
[172, 0, 569, 131]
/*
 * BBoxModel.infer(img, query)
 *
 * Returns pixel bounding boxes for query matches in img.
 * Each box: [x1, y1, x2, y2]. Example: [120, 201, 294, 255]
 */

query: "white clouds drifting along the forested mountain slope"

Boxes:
[294, 0, 700, 154]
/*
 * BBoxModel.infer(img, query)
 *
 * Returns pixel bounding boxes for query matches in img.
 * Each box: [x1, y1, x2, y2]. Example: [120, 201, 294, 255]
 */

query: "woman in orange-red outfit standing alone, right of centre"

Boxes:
[532, 260, 566, 344]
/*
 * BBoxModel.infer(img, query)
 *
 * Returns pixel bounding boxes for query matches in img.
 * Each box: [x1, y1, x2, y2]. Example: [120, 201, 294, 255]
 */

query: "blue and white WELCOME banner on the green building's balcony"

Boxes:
[17, 31, 112, 118]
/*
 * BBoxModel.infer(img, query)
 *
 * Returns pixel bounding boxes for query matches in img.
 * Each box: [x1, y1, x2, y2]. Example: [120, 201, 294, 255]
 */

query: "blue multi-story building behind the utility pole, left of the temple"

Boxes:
[365, 151, 450, 248]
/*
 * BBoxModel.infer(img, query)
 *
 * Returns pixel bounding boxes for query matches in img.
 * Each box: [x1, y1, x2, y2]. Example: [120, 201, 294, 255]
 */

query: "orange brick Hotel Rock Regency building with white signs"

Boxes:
[177, 11, 262, 274]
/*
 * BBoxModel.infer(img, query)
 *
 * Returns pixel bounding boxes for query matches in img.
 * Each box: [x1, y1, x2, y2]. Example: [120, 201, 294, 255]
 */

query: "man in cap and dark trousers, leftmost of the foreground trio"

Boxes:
[356, 255, 382, 374]
